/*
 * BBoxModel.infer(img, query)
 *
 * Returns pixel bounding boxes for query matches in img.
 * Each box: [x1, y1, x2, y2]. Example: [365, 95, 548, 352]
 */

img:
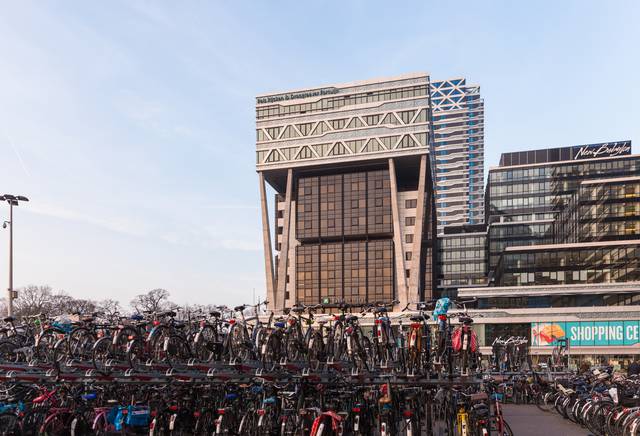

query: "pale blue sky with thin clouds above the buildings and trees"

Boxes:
[0, 0, 640, 304]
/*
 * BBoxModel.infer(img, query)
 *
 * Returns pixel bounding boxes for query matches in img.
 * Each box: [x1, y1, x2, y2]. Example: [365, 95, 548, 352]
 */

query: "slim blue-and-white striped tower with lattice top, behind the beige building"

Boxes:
[431, 78, 484, 233]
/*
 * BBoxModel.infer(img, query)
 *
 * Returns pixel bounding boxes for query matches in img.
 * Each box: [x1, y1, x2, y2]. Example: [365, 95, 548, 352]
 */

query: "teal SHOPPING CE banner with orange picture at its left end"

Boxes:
[531, 321, 640, 347]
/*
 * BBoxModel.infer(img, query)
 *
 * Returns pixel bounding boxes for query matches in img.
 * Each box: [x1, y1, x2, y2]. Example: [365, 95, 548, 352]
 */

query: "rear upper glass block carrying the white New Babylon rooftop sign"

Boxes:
[485, 141, 640, 272]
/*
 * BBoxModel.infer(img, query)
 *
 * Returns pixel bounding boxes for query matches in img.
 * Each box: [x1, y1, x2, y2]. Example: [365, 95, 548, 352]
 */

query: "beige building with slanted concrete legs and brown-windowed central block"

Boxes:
[256, 74, 435, 310]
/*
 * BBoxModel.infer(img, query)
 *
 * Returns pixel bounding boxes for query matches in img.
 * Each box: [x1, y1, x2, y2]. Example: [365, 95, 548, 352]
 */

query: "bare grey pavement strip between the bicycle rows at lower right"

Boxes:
[502, 404, 591, 436]
